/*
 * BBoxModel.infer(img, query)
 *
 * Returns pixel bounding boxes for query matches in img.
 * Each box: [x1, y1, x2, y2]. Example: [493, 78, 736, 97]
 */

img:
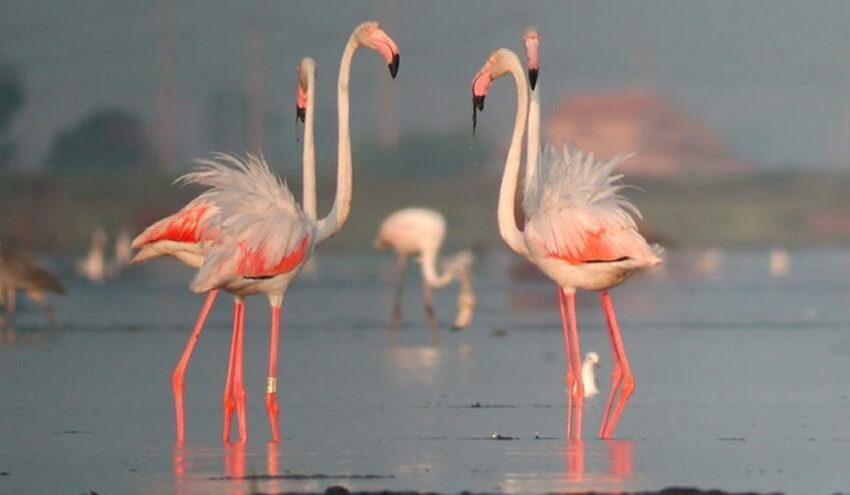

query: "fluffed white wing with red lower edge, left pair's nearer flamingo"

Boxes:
[182, 154, 315, 292]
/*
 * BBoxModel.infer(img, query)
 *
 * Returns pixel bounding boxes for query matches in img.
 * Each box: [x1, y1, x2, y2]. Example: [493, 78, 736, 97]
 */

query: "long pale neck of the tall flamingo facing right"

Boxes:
[318, 33, 360, 242]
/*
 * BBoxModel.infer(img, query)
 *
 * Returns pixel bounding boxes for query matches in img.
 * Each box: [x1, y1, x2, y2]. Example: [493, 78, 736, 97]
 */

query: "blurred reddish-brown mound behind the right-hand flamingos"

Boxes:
[543, 89, 754, 179]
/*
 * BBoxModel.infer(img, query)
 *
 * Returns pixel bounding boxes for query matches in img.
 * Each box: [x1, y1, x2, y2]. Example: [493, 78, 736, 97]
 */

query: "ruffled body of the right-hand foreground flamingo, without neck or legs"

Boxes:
[523, 147, 661, 291]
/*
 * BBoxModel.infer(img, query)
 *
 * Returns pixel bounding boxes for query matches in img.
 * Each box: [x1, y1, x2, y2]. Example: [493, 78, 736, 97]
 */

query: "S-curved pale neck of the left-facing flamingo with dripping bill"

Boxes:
[498, 50, 528, 256]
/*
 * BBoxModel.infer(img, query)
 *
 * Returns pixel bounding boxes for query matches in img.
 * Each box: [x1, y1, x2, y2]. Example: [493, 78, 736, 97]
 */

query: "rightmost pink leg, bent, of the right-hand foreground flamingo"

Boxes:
[599, 291, 635, 438]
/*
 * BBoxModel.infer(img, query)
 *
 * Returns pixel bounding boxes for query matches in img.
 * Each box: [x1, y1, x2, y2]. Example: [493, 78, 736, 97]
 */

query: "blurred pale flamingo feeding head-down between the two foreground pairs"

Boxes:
[374, 208, 475, 330]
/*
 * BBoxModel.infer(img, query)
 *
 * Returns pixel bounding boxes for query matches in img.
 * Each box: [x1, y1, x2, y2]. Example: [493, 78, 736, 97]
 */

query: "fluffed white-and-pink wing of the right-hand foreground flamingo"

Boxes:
[525, 146, 659, 264]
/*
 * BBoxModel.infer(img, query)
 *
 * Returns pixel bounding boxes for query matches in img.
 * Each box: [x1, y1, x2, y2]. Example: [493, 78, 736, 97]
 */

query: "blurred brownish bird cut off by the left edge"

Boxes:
[0, 248, 65, 322]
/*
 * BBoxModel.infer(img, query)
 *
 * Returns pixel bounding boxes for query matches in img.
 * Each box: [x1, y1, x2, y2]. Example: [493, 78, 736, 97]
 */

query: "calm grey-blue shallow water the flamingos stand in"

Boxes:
[0, 251, 850, 494]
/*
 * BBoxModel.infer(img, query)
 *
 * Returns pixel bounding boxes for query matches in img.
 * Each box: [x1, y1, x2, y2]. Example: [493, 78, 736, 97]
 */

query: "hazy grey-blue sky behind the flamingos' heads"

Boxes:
[0, 0, 850, 167]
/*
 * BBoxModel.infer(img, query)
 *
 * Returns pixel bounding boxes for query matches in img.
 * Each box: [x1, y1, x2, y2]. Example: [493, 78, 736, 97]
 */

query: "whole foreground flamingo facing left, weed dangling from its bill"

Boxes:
[472, 48, 661, 439]
